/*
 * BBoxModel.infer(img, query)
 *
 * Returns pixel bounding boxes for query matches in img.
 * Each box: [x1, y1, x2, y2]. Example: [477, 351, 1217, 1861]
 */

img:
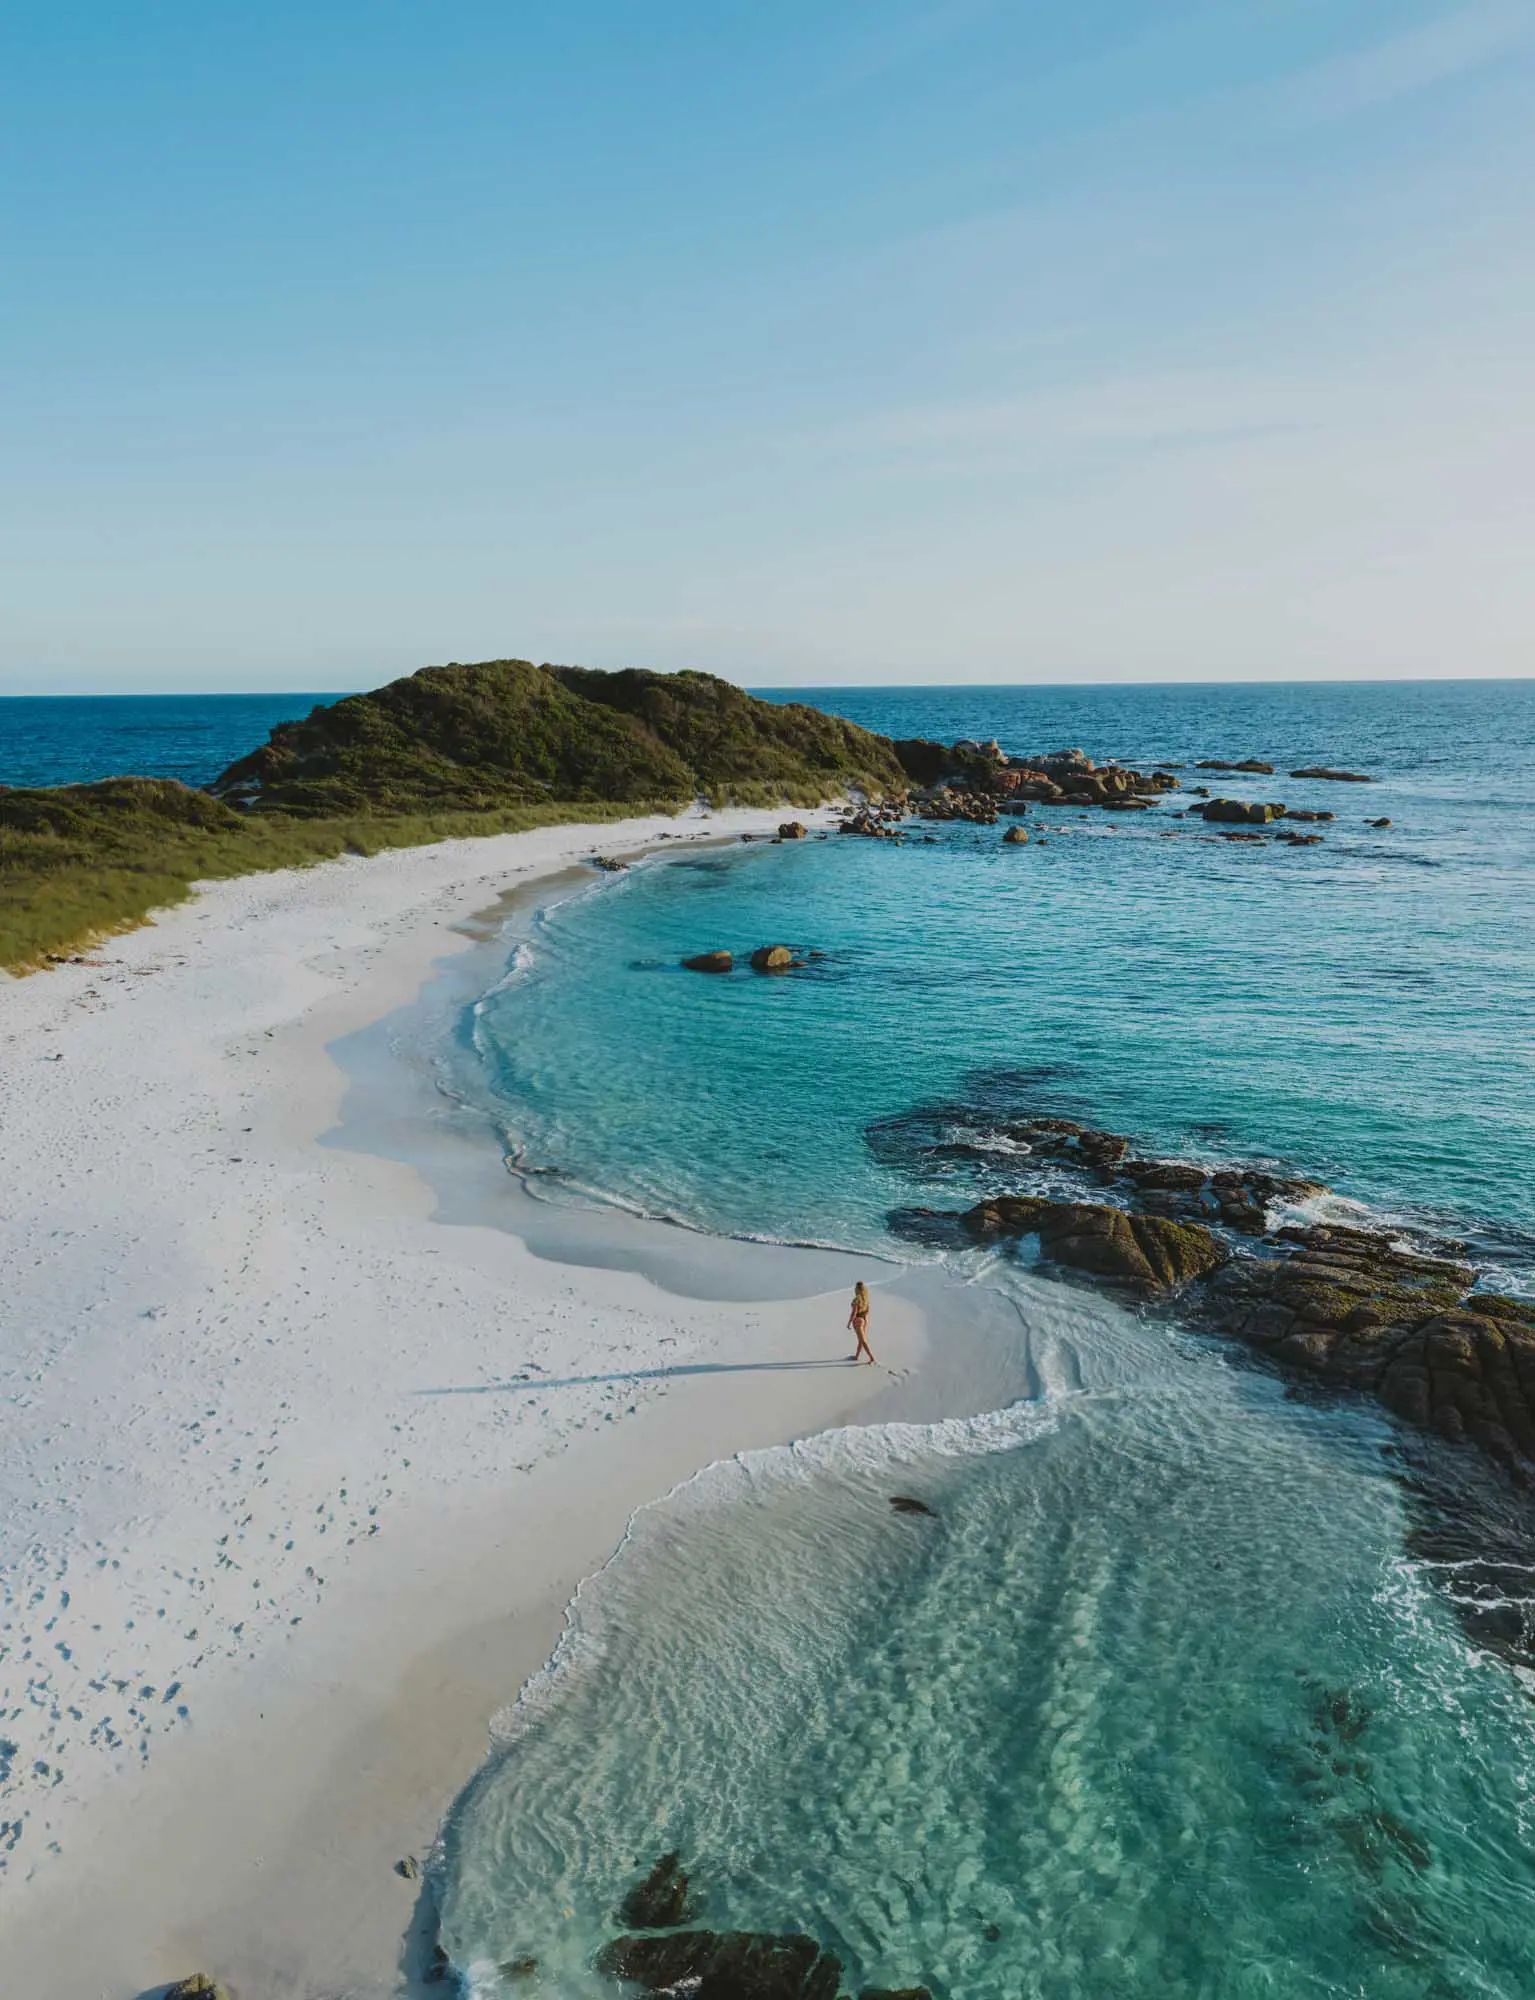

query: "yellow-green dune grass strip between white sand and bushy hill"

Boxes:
[0, 778, 680, 972]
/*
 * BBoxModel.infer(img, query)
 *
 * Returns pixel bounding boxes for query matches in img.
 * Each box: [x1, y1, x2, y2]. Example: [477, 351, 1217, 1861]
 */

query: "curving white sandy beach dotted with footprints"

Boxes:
[0, 812, 959, 2000]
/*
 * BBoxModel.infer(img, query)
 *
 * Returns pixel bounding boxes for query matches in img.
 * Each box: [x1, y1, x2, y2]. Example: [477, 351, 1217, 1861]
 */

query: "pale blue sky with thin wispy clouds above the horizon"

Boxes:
[0, 0, 1535, 692]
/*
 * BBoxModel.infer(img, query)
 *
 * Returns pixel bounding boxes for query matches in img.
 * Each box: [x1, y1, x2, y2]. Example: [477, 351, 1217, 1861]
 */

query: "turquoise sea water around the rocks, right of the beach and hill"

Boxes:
[431, 686, 1535, 2000]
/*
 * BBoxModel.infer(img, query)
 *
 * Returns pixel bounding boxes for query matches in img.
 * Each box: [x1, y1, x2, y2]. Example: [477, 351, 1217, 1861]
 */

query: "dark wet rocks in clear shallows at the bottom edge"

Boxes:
[598, 1854, 931, 2000]
